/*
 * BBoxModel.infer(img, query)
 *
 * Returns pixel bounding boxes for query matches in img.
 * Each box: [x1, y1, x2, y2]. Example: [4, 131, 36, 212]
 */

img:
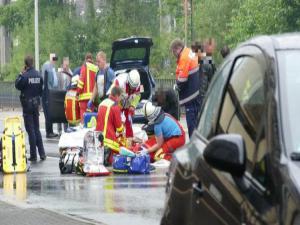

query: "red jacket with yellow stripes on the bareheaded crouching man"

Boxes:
[96, 96, 124, 152]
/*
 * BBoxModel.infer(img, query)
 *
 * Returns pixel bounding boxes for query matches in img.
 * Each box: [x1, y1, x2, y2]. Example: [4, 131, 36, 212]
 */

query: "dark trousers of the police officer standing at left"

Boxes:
[23, 108, 45, 158]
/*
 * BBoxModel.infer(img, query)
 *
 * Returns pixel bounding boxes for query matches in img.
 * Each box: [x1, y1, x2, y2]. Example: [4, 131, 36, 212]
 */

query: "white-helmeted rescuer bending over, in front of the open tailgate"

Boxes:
[108, 69, 141, 138]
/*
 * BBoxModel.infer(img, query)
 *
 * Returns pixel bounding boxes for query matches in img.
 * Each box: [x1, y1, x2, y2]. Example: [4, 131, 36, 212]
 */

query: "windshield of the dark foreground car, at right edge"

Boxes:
[277, 49, 300, 153]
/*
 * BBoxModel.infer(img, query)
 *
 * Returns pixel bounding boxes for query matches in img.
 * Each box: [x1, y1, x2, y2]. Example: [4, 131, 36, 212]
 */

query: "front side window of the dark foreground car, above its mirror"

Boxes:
[218, 56, 265, 169]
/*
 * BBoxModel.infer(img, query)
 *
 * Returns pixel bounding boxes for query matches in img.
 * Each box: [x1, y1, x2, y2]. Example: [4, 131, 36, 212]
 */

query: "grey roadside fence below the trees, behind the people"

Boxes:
[0, 79, 175, 110]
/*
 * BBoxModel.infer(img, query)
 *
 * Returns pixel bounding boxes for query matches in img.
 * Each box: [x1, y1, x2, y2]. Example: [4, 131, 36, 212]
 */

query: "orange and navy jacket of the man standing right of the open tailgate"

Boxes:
[176, 47, 200, 105]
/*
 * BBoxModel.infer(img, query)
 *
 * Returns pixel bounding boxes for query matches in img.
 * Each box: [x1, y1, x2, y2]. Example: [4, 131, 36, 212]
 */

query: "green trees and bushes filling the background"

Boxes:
[0, 0, 300, 80]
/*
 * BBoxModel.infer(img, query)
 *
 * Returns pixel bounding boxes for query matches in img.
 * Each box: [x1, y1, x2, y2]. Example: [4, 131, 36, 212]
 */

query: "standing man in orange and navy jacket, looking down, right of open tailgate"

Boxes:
[170, 39, 201, 137]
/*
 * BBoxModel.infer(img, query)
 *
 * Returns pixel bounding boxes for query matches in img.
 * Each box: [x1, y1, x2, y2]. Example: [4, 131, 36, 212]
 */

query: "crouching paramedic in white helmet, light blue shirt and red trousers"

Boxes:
[142, 102, 185, 161]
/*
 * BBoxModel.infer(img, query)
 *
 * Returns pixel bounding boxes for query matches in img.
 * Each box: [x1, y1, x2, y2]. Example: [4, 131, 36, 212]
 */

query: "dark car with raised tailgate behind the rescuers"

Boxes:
[110, 37, 179, 123]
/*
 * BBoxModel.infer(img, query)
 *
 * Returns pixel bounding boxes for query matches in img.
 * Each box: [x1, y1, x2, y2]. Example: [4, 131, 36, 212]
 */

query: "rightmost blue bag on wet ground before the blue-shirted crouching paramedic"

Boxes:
[129, 154, 150, 174]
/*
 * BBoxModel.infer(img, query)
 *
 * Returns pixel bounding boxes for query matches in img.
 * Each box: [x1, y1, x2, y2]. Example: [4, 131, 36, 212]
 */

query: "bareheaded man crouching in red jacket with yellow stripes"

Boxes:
[96, 87, 124, 165]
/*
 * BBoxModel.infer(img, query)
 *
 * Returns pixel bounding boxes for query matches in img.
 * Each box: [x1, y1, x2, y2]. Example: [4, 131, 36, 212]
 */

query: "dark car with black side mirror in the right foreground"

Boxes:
[161, 34, 300, 225]
